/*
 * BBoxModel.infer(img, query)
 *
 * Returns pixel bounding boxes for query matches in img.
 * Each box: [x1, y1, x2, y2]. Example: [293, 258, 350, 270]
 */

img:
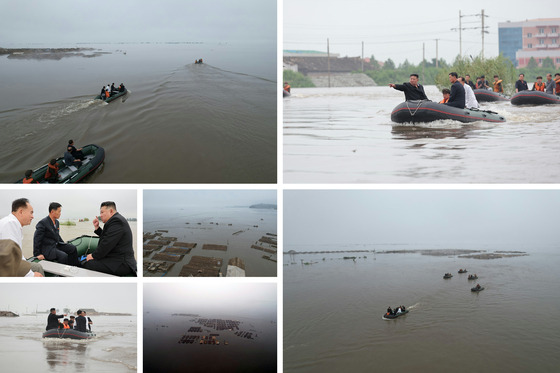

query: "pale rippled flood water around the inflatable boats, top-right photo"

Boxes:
[283, 86, 560, 183]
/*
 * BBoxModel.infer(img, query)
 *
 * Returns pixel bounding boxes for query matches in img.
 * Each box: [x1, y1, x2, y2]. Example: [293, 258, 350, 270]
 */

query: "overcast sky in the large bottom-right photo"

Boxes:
[284, 190, 560, 250]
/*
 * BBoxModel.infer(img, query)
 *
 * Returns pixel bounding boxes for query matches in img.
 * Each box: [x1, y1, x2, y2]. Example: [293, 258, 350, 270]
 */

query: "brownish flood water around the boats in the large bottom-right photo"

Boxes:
[284, 245, 560, 372]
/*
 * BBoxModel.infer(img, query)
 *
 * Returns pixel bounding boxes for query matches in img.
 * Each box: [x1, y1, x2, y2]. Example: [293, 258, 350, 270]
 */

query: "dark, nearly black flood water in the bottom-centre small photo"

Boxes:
[144, 311, 277, 372]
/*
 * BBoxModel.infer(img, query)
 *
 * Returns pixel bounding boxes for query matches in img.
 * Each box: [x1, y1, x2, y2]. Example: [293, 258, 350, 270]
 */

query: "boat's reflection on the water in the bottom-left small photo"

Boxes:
[43, 340, 89, 372]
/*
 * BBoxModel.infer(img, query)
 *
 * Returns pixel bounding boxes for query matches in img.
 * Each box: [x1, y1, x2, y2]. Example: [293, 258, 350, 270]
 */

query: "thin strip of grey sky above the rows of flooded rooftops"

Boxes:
[144, 190, 276, 209]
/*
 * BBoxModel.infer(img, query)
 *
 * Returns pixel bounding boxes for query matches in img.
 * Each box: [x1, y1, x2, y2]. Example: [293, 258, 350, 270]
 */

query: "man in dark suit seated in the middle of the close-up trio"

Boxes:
[33, 202, 78, 266]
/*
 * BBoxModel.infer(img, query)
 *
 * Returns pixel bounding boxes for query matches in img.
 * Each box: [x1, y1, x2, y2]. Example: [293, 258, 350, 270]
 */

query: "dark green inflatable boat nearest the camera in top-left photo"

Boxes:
[16, 144, 105, 184]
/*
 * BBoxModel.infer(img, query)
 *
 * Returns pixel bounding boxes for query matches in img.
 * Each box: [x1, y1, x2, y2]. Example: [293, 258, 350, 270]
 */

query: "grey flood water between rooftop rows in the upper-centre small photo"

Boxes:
[144, 207, 277, 276]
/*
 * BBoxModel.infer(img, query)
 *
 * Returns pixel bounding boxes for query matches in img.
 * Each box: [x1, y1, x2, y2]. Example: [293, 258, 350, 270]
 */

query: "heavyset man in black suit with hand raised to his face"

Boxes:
[84, 202, 136, 276]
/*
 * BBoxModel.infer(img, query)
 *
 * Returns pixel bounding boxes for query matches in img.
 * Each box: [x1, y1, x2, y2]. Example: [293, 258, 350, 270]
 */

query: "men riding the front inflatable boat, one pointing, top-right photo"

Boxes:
[389, 72, 479, 109]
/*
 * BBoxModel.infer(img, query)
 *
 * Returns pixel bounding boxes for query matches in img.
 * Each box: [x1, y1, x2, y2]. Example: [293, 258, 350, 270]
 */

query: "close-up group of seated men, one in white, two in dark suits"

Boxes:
[0, 198, 136, 277]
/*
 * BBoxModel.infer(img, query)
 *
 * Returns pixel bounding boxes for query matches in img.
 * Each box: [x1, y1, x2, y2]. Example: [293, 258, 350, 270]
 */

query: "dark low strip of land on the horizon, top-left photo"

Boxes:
[0, 48, 111, 61]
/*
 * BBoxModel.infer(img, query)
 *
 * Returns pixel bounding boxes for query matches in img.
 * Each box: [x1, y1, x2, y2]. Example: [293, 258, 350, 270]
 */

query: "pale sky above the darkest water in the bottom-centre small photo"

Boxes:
[144, 279, 276, 317]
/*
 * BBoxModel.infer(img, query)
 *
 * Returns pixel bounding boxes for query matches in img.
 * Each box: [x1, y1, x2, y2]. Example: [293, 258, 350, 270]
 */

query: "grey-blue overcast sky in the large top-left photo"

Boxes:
[0, 0, 277, 47]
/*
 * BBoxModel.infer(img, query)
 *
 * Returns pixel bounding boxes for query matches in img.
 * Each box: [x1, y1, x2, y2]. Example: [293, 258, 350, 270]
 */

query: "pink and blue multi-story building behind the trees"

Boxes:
[498, 18, 560, 67]
